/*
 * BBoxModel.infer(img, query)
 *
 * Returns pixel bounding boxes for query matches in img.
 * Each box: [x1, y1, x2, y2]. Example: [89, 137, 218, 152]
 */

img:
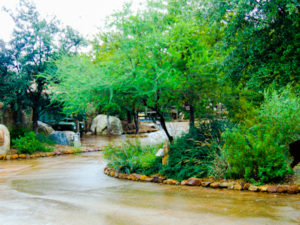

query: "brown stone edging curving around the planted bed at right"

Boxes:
[104, 167, 300, 194]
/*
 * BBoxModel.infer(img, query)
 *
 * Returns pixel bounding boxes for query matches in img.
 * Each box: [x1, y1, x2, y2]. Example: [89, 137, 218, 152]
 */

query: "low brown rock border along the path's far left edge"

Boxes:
[0, 149, 102, 160]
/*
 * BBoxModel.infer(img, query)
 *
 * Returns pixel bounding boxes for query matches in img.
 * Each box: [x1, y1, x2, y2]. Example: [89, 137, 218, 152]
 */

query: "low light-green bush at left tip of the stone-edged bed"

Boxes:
[104, 140, 161, 175]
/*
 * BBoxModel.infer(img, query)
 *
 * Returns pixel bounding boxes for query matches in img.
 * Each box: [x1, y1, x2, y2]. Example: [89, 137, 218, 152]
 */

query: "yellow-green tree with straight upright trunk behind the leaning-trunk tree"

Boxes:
[168, 0, 222, 129]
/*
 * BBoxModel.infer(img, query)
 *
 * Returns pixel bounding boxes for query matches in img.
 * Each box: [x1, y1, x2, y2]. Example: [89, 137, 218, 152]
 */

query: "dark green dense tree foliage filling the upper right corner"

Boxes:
[217, 0, 300, 92]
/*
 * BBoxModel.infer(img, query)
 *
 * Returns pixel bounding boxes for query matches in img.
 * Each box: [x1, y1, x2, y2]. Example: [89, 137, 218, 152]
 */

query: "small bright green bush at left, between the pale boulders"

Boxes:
[13, 132, 53, 154]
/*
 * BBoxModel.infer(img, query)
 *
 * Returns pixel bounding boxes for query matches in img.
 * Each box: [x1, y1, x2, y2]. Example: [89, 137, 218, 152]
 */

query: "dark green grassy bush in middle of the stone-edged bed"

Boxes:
[163, 120, 229, 181]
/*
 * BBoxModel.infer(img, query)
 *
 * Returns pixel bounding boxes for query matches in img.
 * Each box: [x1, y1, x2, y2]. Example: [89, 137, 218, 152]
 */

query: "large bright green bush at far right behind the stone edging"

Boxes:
[224, 89, 300, 183]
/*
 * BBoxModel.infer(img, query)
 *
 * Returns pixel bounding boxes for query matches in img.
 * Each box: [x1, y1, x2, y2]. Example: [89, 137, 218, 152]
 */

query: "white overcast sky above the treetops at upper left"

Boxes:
[0, 0, 146, 42]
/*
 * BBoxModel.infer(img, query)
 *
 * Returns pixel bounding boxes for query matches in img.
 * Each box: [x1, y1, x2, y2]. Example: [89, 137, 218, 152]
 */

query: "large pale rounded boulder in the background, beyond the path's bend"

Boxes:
[91, 114, 123, 135]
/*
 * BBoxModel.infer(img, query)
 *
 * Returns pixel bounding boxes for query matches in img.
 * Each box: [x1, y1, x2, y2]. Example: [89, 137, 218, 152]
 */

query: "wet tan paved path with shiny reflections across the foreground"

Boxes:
[0, 152, 300, 225]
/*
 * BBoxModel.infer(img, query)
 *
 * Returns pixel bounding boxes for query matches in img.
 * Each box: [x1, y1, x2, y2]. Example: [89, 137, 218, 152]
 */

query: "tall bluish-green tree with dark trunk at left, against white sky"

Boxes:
[4, 0, 83, 130]
